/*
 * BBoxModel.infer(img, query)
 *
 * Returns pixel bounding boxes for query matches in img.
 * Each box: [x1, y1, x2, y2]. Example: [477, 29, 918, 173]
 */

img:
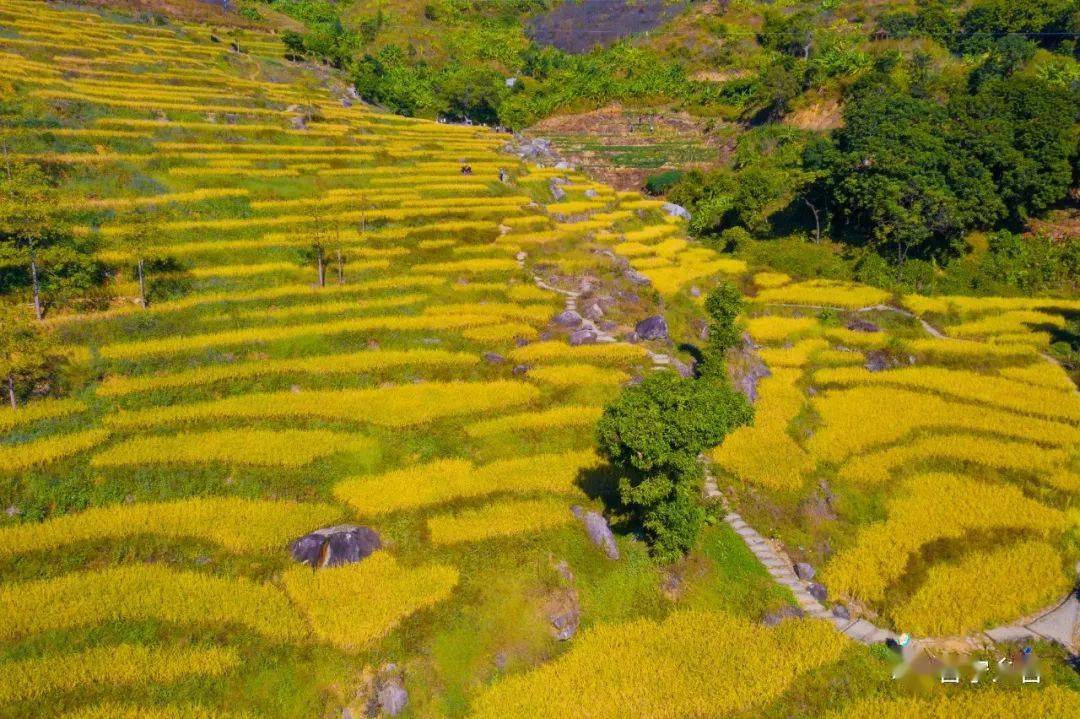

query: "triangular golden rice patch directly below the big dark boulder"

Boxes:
[282, 552, 458, 652]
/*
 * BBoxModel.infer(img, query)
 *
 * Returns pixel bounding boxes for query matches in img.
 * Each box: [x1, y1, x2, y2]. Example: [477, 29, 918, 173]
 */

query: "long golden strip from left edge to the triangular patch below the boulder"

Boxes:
[0, 565, 307, 641]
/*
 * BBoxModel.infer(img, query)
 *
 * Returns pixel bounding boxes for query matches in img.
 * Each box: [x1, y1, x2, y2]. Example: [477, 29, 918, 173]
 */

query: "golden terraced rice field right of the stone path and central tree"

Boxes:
[714, 267, 1080, 636]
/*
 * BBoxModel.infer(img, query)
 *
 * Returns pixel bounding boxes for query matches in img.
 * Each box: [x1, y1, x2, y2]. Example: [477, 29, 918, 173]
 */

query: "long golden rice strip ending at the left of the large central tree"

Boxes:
[334, 451, 599, 515]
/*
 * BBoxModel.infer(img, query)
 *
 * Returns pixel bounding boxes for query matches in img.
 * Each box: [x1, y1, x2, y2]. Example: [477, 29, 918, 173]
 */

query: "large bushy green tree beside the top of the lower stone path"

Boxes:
[597, 371, 753, 561]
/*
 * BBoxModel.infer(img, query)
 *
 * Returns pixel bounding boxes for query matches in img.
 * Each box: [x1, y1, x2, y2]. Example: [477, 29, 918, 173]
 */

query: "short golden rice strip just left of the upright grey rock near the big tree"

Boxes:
[428, 499, 573, 544]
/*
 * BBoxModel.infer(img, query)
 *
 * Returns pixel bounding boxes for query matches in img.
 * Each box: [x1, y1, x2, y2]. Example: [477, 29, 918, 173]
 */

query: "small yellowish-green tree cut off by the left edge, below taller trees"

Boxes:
[0, 302, 59, 409]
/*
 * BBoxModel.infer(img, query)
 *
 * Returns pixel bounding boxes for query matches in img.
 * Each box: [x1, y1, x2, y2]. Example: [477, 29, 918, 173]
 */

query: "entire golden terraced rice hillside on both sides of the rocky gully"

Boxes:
[0, 0, 1080, 719]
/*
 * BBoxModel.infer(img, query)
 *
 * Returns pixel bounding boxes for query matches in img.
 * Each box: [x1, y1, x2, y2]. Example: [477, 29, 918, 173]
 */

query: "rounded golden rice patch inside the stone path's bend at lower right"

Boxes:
[889, 542, 1072, 637]
